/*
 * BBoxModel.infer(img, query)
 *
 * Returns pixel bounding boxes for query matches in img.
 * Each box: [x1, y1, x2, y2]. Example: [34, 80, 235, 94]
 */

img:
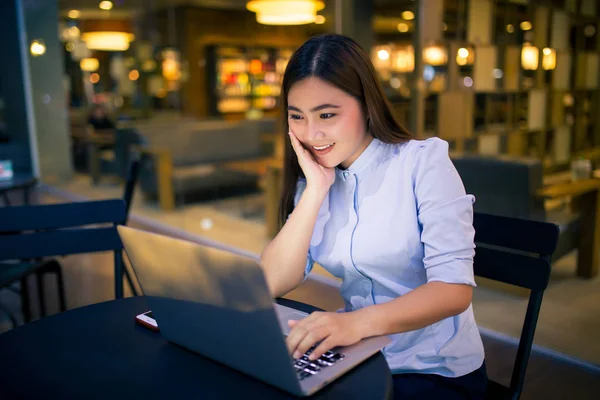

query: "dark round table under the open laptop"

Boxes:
[0, 297, 393, 400]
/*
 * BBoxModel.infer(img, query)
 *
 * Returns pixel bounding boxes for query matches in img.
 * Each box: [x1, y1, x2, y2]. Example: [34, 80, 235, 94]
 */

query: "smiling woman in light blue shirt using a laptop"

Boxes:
[261, 35, 487, 399]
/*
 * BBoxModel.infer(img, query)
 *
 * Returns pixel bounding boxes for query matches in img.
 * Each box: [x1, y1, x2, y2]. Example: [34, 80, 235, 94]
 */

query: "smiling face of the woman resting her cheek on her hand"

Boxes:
[288, 77, 373, 168]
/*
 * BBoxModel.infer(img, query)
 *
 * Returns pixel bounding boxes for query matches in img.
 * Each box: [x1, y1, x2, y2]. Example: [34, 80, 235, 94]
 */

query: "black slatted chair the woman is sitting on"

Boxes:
[473, 213, 559, 399]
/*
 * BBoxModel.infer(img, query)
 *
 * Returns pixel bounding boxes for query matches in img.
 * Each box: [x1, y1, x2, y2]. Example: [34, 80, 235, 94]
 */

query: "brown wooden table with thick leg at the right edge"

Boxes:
[537, 178, 600, 278]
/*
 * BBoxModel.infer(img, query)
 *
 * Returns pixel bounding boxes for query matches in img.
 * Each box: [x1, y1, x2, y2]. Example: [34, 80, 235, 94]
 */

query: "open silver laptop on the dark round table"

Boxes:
[118, 226, 390, 396]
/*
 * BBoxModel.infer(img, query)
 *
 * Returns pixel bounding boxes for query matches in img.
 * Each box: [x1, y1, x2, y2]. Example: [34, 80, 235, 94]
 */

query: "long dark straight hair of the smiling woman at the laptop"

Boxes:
[279, 34, 413, 226]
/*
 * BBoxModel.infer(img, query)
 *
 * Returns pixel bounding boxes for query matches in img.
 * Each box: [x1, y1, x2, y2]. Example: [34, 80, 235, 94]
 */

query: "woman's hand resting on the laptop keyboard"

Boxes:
[286, 312, 364, 360]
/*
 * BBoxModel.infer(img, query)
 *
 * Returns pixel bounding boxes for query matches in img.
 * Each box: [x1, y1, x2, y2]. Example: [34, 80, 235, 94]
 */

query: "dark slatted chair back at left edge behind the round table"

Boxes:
[0, 199, 126, 314]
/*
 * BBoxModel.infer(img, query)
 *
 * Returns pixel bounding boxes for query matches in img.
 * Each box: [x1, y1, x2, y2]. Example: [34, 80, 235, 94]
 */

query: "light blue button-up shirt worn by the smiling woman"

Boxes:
[295, 138, 484, 377]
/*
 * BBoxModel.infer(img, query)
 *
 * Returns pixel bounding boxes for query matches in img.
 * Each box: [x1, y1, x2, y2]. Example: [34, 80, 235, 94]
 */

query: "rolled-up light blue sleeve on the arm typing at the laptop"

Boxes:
[413, 138, 476, 286]
